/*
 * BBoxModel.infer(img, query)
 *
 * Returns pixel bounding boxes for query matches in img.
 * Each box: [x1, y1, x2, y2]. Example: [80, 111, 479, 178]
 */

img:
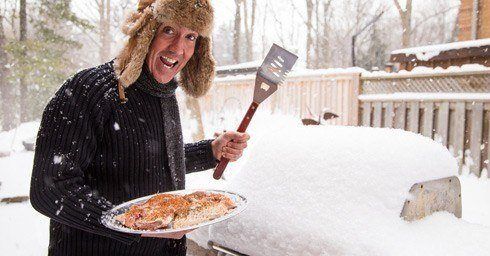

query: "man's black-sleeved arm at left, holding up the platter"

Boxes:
[30, 71, 139, 243]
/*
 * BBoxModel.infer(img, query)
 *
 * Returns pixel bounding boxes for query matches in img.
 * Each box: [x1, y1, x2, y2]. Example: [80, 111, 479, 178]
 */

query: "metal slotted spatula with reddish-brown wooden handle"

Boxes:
[213, 44, 298, 180]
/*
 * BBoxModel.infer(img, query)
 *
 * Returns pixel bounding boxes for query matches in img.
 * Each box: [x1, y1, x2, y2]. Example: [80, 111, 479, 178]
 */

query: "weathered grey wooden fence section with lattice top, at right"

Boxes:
[359, 71, 490, 176]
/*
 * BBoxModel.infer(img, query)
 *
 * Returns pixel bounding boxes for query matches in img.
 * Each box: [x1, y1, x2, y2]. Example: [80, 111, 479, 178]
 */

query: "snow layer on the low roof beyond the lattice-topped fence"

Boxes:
[391, 38, 490, 61]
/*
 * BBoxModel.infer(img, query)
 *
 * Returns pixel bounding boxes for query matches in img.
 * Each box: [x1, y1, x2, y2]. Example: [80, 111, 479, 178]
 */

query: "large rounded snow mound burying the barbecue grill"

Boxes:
[205, 126, 490, 255]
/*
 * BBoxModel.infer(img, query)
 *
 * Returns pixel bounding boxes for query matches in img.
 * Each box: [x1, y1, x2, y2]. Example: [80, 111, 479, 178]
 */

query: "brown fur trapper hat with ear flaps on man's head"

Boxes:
[114, 0, 215, 102]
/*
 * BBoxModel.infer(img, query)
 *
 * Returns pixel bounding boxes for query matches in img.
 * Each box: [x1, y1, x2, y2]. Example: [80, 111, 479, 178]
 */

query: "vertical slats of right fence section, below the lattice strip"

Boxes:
[360, 95, 490, 176]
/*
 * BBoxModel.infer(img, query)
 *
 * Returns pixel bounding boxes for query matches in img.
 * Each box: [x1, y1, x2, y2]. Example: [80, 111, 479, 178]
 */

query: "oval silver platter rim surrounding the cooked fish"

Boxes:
[101, 189, 247, 234]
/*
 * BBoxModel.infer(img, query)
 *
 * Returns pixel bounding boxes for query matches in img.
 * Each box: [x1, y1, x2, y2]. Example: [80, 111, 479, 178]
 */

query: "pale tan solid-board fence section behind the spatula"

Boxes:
[201, 73, 360, 125]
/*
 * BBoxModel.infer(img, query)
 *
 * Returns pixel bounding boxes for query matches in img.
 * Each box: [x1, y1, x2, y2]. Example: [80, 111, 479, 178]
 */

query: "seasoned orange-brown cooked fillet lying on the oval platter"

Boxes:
[116, 191, 236, 230]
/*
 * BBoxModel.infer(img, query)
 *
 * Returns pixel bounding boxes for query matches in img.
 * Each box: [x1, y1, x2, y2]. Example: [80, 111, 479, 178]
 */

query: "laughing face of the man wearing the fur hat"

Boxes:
[146, 25, 198, 83]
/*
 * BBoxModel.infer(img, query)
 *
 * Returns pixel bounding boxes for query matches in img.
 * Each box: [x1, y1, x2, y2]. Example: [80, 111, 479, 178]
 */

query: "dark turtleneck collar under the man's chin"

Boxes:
[134, 63, 178, 98]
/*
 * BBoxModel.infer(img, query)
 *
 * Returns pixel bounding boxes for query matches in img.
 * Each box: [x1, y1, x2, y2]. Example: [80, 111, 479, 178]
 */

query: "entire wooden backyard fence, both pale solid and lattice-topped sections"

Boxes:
[201, 71, 490, 176]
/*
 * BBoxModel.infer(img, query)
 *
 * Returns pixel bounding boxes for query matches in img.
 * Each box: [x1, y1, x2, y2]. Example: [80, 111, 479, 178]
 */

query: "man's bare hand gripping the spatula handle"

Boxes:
[211, 131, 250, 162]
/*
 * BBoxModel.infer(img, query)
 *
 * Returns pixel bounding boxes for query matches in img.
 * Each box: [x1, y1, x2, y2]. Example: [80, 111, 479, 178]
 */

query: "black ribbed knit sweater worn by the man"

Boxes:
[30, 62, 216, 256]
